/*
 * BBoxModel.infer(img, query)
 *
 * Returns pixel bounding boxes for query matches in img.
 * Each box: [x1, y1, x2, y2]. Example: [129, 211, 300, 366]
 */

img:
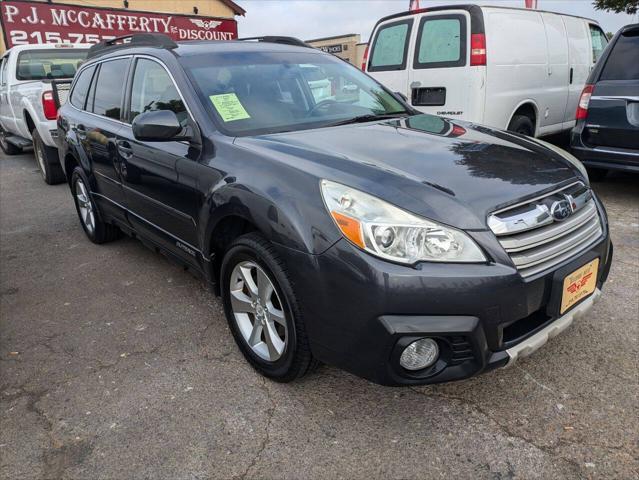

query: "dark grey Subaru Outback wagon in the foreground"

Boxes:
[58, 35, 612, 385]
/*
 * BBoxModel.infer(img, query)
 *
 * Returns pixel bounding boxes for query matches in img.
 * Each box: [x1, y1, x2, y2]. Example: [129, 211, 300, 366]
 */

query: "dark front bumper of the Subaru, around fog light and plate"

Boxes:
[282, 217, 612, 385]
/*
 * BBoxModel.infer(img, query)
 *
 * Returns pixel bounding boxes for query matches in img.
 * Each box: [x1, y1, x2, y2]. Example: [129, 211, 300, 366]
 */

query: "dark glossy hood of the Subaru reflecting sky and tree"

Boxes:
[236, 114, 581, 229]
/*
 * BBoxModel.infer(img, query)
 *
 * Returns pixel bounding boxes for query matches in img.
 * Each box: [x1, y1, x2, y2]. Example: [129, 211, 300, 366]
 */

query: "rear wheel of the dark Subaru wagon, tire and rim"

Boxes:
[71, 167, 120, 244]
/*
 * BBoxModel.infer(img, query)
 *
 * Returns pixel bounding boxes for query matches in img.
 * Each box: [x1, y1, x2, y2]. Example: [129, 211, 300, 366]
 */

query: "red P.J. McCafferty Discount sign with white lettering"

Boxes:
[0, 0, 237, 48]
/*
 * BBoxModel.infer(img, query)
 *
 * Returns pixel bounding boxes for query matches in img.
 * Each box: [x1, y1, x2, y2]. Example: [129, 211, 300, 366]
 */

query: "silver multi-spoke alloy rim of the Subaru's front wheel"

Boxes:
[229, 261, 288, 362]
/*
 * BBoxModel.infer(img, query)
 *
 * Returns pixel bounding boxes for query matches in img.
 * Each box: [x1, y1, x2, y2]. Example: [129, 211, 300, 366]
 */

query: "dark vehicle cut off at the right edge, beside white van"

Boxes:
[571, 24, 639, 180]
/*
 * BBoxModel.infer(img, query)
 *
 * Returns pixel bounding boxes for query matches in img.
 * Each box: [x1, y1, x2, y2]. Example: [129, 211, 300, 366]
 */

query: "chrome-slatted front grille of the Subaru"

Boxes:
[488, 182, 603, 278]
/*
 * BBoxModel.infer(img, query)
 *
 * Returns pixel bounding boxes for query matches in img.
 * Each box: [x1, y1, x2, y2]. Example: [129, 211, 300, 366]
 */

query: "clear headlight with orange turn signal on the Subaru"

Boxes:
[321, 180, 486, 264]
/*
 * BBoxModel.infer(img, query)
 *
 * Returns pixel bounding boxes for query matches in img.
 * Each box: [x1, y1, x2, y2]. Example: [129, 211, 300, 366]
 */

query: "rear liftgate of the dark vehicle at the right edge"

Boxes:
[584, 27, 639, 151]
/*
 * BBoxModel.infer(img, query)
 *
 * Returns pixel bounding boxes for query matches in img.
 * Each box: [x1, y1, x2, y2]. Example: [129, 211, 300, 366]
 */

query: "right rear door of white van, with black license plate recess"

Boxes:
[408, 11, 478, 120]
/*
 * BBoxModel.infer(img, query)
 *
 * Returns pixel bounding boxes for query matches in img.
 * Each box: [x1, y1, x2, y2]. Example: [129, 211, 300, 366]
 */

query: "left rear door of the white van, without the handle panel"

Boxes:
[366, 17, 413, 96]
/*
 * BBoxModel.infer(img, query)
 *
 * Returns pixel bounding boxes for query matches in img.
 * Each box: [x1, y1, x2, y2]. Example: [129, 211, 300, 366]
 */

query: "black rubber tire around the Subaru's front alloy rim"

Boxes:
[220, 233, 318, 383]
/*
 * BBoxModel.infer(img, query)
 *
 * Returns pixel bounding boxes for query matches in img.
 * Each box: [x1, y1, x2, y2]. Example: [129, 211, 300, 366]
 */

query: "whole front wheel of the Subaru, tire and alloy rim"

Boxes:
[220, 233, 317, 382]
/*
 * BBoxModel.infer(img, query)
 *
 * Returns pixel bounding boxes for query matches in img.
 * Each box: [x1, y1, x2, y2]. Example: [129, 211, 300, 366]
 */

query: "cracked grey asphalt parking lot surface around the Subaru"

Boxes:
[0, 154, 639, 479]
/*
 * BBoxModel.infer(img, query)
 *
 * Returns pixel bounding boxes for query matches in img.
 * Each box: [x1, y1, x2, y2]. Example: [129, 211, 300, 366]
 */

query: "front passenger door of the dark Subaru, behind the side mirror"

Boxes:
[117, 58, 201, 263]
